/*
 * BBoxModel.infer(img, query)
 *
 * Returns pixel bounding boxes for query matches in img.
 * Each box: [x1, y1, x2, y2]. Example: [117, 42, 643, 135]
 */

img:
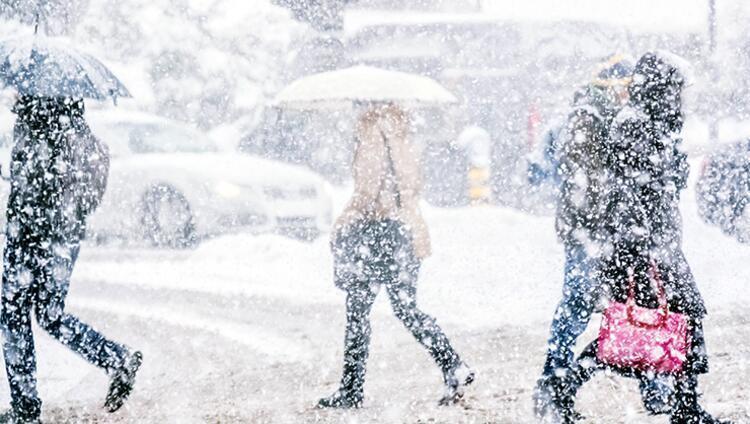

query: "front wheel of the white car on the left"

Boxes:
[141, 185, 196, 248]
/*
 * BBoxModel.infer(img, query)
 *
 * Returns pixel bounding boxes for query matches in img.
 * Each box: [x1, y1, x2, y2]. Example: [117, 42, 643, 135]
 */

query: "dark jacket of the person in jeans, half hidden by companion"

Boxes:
[555, 85, 620, 246]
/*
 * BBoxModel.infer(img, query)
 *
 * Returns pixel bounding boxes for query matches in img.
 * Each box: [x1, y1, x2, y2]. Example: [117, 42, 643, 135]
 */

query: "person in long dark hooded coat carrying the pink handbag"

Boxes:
[560, 53, 736, 424]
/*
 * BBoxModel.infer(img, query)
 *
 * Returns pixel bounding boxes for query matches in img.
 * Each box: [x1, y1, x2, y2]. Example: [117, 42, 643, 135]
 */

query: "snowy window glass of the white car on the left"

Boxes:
[95, 123, 216, 156]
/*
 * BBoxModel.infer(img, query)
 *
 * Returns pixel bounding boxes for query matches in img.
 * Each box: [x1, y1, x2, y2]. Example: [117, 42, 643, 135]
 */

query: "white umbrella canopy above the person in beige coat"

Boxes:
[275, 66, 457, 108]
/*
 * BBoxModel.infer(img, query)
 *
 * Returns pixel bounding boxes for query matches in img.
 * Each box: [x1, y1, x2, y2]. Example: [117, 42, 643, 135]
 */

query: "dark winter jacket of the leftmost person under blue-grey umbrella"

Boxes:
[6, 97, 109, 248]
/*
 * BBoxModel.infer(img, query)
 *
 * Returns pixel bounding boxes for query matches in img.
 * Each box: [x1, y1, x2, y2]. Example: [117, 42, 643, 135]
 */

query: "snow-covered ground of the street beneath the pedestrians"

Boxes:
[0, 167, 750, 423]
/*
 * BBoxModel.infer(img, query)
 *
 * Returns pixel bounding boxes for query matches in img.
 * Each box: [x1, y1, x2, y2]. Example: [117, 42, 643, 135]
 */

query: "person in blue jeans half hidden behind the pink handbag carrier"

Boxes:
[533, 55, 659, 418]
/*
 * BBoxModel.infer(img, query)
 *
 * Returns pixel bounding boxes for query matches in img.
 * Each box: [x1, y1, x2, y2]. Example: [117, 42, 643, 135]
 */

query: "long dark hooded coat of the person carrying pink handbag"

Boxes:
[601, 54, 706, 320]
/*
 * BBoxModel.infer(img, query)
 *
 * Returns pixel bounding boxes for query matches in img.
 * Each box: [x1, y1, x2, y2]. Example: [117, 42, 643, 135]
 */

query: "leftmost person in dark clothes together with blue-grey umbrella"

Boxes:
[0, 38, 143, 423]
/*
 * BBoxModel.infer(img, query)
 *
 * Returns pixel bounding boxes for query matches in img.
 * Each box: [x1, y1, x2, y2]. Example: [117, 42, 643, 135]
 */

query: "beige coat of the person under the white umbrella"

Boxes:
[334, 106, 431, 258]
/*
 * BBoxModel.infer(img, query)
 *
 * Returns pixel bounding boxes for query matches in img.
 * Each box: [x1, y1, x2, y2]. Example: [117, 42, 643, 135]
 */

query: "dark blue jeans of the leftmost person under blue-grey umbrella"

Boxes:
[0, 239, 127, 420]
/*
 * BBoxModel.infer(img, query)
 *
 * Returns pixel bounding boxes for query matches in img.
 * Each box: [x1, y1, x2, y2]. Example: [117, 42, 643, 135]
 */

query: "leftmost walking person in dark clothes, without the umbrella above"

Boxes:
[0, 96, 142, 422]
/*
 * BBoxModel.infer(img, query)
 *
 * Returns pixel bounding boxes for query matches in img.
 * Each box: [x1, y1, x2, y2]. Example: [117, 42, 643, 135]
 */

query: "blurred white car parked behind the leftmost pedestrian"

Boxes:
[0, 110, 332, 247]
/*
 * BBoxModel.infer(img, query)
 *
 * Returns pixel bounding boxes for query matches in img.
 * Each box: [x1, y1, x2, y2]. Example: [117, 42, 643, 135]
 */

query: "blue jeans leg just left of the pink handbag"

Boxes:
[542, 246, 598, 377]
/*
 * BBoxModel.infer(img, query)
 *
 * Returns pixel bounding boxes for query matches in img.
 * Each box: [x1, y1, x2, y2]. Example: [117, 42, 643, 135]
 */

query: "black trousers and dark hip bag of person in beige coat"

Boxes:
[335, 221, 460, 396]
